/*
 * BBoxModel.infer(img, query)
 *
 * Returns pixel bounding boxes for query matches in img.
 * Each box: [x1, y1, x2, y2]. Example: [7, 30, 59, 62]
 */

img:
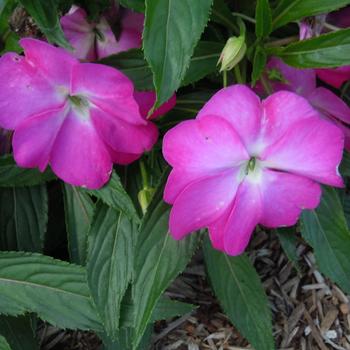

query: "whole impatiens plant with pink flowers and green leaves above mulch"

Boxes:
[0, 0, 350, 350]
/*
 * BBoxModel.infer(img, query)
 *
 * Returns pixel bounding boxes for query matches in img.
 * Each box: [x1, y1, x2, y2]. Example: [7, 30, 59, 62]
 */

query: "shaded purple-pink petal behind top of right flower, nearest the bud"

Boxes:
[266, 57, 316, 96]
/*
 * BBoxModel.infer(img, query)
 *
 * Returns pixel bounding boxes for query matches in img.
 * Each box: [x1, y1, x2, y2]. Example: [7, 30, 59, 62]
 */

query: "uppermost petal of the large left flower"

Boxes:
[20, 38, 79, 89]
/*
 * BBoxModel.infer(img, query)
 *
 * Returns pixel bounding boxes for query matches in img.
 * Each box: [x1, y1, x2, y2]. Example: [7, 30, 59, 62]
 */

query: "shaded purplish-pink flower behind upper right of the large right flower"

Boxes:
[258, 57, 350, 151]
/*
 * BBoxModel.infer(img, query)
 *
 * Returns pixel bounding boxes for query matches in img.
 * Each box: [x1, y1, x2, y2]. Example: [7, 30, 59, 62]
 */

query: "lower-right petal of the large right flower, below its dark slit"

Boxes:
[260, 169, 321, 227]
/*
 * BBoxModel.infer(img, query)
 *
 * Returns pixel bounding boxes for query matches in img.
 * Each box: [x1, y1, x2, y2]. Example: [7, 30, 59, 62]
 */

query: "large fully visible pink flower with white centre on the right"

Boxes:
[163, 85, 344, 255]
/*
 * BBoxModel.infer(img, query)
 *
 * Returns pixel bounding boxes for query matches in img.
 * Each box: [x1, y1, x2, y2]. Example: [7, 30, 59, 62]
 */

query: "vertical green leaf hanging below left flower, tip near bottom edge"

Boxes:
[87, 203, 135, 339]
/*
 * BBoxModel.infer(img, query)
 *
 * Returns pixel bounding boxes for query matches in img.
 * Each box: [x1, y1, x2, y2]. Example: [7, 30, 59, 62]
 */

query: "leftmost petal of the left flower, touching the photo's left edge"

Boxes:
[0, 52, 65, 129]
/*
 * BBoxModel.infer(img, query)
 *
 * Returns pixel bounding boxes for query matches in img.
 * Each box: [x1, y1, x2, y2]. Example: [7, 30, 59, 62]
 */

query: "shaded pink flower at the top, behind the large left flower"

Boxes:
[61, 6, 144, 61]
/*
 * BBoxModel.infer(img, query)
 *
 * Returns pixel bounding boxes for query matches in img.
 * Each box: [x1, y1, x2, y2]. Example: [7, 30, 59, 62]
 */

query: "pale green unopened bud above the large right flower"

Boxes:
[218, 35, 247, 72]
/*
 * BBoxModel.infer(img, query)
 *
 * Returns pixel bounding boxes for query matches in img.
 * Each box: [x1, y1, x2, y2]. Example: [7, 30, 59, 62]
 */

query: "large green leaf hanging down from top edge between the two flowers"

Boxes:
[143, 0, 212, 107]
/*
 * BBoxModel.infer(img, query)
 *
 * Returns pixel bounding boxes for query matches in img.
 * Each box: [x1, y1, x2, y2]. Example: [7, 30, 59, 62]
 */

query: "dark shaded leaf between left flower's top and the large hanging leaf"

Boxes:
[100, 49, 154, 91]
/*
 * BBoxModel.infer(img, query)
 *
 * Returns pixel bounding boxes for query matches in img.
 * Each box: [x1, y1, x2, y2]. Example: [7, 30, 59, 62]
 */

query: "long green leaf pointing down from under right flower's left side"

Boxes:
[134, 178, 198, 345]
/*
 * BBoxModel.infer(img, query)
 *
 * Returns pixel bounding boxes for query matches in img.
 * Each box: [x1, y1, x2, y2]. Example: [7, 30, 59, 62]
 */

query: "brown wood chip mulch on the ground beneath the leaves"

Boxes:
[41, 232, 350, 350]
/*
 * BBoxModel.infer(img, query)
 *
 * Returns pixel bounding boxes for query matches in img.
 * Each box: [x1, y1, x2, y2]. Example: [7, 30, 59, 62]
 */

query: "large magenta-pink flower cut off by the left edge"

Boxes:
[0, 39, 157, 189]
